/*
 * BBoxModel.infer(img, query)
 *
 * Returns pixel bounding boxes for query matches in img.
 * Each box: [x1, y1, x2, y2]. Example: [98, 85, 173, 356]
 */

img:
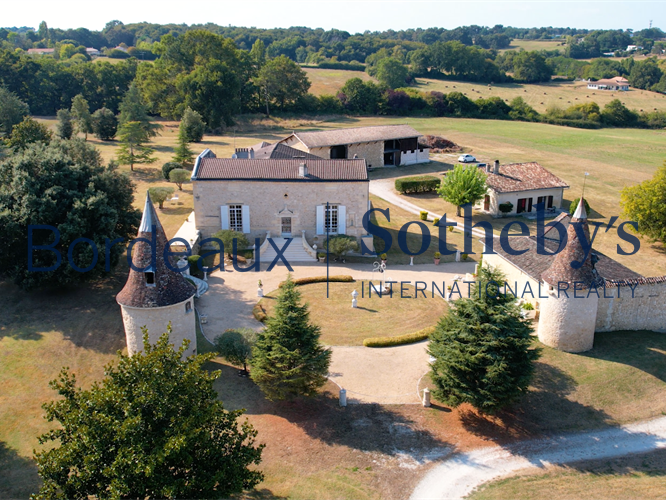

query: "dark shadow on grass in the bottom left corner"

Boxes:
[0, 441, 41, 500]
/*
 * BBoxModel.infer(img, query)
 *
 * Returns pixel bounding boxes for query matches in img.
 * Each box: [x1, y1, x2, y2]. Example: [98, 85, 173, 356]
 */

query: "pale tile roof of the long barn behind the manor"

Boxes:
[283, 125, 423, 148]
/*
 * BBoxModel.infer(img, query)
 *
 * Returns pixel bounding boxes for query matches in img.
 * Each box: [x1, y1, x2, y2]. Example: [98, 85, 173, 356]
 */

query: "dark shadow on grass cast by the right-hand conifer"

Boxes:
[460, 362, 613, 442]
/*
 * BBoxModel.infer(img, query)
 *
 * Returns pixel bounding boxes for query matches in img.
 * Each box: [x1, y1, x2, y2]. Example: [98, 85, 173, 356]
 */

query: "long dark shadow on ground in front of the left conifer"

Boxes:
[207, 360, 450, 463]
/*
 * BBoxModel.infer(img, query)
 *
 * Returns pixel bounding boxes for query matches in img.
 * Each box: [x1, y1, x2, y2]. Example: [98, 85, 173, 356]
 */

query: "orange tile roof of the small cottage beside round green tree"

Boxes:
[479, 162, 569, 193]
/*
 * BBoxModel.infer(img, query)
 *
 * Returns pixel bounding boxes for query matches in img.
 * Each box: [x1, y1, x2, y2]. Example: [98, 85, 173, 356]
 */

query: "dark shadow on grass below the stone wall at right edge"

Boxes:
[579, 331, 666, 382]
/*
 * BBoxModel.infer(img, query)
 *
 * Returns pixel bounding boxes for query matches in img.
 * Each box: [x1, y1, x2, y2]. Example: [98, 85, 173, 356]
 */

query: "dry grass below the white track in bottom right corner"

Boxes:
[468, 450, 666, 500]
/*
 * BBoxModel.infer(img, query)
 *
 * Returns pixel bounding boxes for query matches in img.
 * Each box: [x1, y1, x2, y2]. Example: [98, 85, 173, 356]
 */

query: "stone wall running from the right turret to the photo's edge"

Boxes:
[596, 277, 666, 332]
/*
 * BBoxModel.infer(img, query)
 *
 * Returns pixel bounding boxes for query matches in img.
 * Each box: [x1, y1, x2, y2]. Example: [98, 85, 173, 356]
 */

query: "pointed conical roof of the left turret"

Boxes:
[116, 194, 196, 308]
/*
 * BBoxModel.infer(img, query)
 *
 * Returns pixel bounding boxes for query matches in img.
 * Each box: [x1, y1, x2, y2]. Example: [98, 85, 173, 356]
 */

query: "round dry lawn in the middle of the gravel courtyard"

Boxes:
[259, 280, 448, 345]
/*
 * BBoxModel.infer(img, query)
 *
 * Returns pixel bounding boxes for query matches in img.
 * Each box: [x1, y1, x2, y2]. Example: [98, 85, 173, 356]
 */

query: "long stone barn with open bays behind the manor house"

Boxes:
[280, 125, 430, 168]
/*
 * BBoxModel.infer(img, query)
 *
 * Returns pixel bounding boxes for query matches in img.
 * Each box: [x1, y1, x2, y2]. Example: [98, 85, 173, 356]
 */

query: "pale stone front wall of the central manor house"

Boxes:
[192, 181, 370, 243]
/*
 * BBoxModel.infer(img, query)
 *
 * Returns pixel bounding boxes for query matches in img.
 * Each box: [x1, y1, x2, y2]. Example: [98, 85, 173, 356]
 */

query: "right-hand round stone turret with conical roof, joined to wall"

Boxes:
[538, 197, 603, 352]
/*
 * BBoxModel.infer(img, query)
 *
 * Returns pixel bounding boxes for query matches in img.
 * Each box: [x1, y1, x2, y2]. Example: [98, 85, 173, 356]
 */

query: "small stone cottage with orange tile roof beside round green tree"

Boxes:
[474, 161, 569, 217]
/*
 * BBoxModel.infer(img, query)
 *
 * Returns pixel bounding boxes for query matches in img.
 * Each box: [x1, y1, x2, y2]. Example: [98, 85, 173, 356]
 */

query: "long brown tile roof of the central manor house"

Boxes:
[192, 158, 368, 182]
